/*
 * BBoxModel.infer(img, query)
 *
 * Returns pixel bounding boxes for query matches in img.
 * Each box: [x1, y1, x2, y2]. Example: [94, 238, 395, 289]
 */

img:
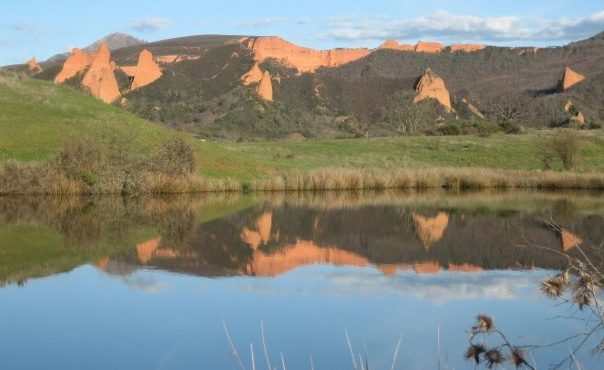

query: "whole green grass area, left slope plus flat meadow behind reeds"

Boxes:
[0, 71, 604, 192]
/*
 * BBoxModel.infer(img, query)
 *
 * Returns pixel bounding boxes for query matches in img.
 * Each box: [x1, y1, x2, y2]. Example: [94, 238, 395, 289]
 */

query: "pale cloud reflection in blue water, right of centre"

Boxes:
[316, 269, 547, 303]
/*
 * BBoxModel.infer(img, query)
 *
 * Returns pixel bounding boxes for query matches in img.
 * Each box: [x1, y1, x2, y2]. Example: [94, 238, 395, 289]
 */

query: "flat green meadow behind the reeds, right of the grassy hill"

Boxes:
[223, 130, 604, 176]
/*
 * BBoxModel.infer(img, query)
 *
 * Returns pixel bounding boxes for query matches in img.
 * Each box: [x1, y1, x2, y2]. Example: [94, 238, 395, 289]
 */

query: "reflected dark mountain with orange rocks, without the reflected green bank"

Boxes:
[119, 205, 604, 276]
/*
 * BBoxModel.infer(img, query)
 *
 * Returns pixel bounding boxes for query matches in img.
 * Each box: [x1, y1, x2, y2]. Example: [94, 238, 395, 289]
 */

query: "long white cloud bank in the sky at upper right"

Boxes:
[325, 10, 604, 42]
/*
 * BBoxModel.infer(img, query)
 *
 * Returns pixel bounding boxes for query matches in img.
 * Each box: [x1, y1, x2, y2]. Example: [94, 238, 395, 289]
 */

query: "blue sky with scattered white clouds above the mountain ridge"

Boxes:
[0, 0, 604, 65]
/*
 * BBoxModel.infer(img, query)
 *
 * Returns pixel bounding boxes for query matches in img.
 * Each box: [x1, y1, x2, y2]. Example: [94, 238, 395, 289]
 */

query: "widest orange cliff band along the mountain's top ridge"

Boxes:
[243, 36, 370, 72]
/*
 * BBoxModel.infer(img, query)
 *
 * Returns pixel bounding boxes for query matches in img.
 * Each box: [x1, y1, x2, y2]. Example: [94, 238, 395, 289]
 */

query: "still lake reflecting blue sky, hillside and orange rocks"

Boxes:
[0, 192, 604, 370]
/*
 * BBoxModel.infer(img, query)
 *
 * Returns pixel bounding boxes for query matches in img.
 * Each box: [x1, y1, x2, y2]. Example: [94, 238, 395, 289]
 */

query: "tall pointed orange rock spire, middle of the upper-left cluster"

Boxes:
[82, 43, 121, 103]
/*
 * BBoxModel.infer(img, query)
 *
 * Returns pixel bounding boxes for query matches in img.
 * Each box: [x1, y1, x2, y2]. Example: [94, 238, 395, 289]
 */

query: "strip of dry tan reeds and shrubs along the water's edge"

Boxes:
[0, 168, 604, 195]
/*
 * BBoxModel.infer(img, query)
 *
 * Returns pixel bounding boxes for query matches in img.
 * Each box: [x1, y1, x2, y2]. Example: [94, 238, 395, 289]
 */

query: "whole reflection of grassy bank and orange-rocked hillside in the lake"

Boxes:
[0, 192, 604, 284]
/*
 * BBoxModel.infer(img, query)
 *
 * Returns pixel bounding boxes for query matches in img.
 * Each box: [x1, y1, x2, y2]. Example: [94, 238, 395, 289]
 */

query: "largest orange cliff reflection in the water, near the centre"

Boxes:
[246, 240, 369, 276]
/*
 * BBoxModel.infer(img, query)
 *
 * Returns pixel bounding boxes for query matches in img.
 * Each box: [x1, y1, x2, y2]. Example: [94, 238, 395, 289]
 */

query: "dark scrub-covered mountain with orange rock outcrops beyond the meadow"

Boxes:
[21, 34, 604, 139]
